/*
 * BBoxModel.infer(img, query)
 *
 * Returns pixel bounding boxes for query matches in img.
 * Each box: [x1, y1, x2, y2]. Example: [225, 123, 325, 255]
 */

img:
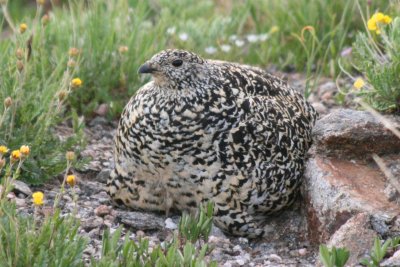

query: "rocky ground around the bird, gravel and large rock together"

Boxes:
[7, 74, 400, 266]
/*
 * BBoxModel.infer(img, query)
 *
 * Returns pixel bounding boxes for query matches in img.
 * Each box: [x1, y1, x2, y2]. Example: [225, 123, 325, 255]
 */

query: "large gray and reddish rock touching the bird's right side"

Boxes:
[303, 109, 400, 243]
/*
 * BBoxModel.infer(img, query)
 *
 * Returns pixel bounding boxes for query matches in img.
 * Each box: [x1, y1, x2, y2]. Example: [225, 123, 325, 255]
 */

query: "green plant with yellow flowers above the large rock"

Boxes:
[353, 12, 400, 112]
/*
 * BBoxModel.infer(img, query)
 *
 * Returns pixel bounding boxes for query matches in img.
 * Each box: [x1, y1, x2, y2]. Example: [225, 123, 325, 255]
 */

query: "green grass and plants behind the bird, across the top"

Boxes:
[0, 0, 400, 183]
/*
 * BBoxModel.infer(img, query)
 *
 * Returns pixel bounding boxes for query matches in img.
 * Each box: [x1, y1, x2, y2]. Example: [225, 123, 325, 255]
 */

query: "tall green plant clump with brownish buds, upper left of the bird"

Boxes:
[0, 1, 84, 183]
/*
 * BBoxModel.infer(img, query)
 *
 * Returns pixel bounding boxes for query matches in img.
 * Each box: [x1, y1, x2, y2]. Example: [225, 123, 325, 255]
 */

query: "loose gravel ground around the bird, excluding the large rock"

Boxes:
[14, 74, 350, 266]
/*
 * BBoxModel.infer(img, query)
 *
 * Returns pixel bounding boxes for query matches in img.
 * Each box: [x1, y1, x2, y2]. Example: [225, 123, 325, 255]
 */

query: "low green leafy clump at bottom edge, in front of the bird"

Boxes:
[91, 203, 217, 267]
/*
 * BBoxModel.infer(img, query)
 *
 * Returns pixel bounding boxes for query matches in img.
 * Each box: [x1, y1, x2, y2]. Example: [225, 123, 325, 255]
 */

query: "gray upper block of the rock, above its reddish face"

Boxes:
[313, 109, 400, 158]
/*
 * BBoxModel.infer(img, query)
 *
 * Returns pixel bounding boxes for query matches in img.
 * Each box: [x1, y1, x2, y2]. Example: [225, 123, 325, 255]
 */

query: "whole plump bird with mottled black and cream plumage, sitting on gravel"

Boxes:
[108, 50, 317, 237]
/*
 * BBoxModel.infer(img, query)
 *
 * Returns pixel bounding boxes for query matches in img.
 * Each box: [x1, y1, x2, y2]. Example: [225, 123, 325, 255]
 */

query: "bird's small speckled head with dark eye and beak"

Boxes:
[138, 49, 206, 89]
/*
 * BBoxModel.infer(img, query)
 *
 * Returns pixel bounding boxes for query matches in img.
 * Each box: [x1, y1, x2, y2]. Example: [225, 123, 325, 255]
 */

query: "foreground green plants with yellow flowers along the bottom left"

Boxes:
[0, 150, 217, 267]
